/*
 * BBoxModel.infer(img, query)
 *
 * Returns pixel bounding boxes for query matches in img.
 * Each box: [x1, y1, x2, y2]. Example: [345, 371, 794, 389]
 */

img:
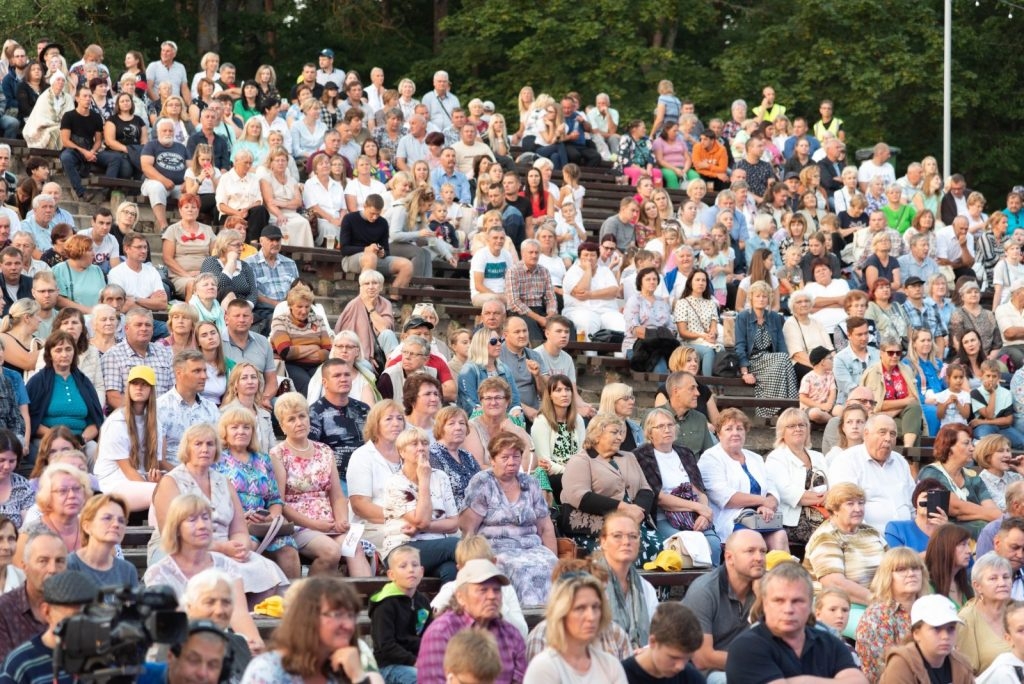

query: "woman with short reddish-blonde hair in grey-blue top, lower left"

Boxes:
[68, 494, 138, 589]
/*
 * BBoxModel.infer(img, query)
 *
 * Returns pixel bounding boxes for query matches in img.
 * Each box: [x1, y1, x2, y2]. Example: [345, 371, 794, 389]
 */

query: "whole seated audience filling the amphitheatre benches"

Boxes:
[0, 34, 1024, 684]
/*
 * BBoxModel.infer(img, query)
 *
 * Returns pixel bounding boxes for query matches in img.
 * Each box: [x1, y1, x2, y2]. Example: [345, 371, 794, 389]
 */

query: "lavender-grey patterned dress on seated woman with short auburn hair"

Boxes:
[466, 470, 558, 607]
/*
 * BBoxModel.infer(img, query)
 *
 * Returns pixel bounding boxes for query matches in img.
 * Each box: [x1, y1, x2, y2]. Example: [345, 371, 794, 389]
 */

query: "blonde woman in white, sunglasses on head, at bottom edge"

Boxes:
[522, 573, 627, 684]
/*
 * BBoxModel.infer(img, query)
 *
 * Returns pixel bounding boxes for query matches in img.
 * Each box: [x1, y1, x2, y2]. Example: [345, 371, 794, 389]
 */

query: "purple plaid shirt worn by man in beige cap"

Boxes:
[416, 610, 526, 684]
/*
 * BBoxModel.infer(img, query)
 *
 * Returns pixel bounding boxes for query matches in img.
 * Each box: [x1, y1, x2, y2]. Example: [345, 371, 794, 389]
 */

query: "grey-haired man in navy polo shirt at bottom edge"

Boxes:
[726, 562, 867, 684]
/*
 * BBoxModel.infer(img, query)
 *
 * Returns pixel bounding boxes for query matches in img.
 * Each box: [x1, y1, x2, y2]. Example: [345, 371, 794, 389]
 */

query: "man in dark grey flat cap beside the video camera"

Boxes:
[0, 570, 99, 684]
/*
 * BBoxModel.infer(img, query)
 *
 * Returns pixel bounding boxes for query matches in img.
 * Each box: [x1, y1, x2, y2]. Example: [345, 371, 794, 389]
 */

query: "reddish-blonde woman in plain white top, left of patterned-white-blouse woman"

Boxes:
[348, 399, 406, 548]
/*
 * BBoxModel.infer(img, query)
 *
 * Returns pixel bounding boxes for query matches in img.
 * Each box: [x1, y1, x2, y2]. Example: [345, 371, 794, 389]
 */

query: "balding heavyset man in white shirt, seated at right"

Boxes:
[828, 414, 913, 533]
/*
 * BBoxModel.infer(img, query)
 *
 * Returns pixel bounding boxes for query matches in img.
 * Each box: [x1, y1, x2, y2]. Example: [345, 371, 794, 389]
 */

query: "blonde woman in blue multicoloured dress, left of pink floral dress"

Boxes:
[213, 407, 302, 580]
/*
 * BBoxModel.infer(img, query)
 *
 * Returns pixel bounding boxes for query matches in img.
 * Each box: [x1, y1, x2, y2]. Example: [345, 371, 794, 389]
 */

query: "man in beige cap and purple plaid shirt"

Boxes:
[416, 558, 526, 684]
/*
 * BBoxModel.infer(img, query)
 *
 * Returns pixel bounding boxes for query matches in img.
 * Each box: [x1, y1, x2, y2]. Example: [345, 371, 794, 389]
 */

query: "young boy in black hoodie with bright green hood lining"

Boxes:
[370, 545, 430, 684]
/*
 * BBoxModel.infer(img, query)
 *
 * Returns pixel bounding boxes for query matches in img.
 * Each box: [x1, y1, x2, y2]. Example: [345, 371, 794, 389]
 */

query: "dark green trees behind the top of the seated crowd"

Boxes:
[6, 0, 1024, 194]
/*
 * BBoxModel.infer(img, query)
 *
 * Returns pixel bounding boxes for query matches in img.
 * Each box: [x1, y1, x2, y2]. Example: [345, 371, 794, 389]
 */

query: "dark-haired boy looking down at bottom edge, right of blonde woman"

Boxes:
[623, 602, 705, 684]
